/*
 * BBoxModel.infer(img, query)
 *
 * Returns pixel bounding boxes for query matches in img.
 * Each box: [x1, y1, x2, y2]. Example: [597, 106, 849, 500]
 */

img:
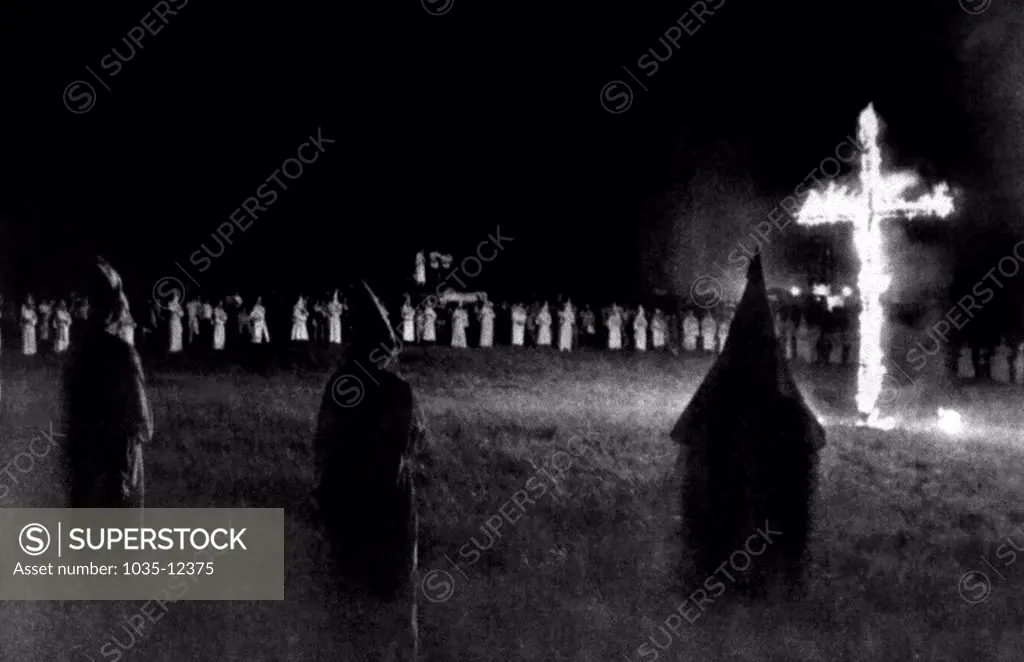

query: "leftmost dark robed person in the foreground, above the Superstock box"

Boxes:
[63, 259, 153, 508]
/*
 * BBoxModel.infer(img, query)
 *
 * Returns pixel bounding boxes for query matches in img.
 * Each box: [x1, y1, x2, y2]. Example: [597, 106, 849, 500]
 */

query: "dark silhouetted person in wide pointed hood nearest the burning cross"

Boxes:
[672, 255, 824, 597]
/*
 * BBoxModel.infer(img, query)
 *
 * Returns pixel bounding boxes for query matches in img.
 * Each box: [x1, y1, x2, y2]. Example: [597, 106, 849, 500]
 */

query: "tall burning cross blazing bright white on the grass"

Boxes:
[797, 104, 953, 427]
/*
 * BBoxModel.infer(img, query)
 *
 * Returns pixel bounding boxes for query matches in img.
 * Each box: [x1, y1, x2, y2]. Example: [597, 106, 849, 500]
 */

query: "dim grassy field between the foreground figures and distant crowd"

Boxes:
[0, 348, 1024, 662]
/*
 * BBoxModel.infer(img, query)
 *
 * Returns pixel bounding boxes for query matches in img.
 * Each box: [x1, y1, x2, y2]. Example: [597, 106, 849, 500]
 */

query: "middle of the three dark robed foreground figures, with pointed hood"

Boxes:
[313, 282, 425, 660]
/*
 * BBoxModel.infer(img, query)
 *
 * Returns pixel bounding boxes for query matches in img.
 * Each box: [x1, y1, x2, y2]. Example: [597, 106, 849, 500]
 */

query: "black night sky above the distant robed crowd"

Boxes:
[0, 0, 1024, 323]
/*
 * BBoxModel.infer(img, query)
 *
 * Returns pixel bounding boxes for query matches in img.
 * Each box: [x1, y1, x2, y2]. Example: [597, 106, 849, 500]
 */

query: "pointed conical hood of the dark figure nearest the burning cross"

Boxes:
[672, 255, 823, 446]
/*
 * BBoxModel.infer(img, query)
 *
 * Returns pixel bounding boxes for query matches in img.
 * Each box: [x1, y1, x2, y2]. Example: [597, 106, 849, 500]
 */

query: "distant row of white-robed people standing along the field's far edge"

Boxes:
[8, 290, 1024, 384]
